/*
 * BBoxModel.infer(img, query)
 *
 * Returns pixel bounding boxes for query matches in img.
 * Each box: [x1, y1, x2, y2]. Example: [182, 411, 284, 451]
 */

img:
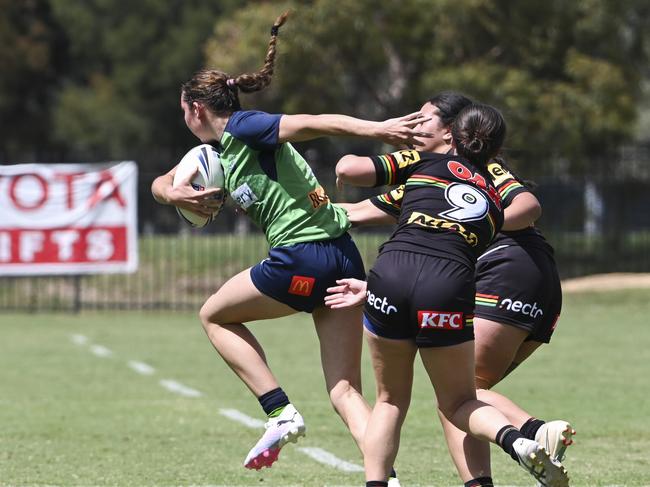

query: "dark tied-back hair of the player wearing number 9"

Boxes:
[451, 104, 506, 167]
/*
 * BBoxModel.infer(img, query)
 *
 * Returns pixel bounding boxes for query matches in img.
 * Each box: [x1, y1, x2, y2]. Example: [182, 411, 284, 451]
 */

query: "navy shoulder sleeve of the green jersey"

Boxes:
[226, 110, 282, 150]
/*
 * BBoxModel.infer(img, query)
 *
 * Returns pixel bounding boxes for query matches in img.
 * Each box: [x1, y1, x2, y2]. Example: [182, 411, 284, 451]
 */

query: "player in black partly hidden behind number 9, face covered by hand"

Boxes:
[326, 92, 575, 487]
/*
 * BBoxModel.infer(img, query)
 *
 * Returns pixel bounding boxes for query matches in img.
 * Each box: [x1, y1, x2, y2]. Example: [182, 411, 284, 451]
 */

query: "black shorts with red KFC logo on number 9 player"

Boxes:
[364, 250, 475, 347]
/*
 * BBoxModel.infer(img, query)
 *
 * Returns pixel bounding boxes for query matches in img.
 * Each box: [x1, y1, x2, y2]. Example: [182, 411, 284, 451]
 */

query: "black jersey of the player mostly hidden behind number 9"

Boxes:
[370, 161, 553, 254]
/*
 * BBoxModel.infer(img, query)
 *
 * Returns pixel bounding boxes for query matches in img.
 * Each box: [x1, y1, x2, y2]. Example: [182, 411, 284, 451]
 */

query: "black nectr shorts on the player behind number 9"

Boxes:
[474, 245, 562, 343]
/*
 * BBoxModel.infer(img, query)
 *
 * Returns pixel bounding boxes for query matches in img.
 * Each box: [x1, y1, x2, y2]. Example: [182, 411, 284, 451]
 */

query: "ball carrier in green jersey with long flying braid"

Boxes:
[152, 14, 428, 476]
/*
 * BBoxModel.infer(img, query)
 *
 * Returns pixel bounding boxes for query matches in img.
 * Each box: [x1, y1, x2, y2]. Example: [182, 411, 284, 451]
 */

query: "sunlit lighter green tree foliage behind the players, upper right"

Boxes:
[207, 0, 650, 174]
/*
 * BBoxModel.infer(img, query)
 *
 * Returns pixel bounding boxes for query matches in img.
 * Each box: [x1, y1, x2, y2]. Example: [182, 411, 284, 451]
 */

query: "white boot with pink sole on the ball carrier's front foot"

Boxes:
[244, 404, 306, 470]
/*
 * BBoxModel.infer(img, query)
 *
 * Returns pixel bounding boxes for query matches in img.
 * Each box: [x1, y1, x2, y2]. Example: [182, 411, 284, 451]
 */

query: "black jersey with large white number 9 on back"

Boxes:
[372, 150, 503, 267]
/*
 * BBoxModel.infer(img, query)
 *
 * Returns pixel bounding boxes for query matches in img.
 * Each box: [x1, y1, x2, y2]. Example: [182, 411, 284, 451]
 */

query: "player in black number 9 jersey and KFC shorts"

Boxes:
[328, 105, 568, 487]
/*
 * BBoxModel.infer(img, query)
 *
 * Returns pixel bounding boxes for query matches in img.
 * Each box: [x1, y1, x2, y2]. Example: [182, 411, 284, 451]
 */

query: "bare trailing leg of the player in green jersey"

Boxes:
[312, 308, 370, 453]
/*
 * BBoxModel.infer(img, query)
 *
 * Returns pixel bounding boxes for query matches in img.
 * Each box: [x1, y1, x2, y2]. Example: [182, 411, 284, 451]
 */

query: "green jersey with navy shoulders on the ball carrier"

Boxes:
[219, 111, 350, 247]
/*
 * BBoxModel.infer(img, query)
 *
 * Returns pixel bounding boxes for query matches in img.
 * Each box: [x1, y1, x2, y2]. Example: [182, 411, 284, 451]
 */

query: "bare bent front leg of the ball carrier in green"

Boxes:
[199, 269, 296, 397]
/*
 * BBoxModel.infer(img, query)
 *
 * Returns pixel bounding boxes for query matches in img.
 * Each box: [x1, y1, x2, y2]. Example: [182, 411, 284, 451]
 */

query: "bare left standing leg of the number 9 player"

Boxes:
[363, 330, 417, 480]
